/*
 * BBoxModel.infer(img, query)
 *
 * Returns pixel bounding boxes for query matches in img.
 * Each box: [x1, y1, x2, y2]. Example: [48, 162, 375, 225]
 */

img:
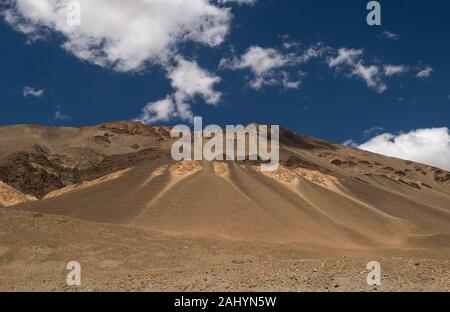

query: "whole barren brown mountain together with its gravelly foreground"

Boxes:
[0, 121, 450, 290]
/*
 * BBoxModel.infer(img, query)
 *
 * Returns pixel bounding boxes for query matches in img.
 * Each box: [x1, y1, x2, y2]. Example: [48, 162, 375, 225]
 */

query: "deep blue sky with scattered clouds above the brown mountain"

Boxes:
[0, 0, 450, 149]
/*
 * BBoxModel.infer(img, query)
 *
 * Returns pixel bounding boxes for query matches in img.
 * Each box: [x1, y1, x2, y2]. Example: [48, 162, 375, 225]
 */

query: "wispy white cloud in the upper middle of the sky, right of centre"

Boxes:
[219, 43, 326, 90]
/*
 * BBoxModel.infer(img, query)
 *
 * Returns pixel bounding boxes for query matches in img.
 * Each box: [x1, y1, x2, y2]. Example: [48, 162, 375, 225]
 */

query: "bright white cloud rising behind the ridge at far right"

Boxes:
[357, 127, 450, 170]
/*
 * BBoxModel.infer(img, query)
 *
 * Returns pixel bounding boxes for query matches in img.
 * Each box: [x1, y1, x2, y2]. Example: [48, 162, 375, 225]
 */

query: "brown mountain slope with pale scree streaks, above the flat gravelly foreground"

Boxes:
[0, 122, 450, 248]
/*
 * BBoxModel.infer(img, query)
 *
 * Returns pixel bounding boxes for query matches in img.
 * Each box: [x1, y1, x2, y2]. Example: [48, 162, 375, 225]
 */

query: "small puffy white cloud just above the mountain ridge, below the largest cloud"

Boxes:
[138, 57, 222, 124]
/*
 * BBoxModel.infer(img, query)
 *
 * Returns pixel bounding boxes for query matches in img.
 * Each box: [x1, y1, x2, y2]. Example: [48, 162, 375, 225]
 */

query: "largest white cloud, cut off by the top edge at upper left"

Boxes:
[2, 0, 231, 72]
